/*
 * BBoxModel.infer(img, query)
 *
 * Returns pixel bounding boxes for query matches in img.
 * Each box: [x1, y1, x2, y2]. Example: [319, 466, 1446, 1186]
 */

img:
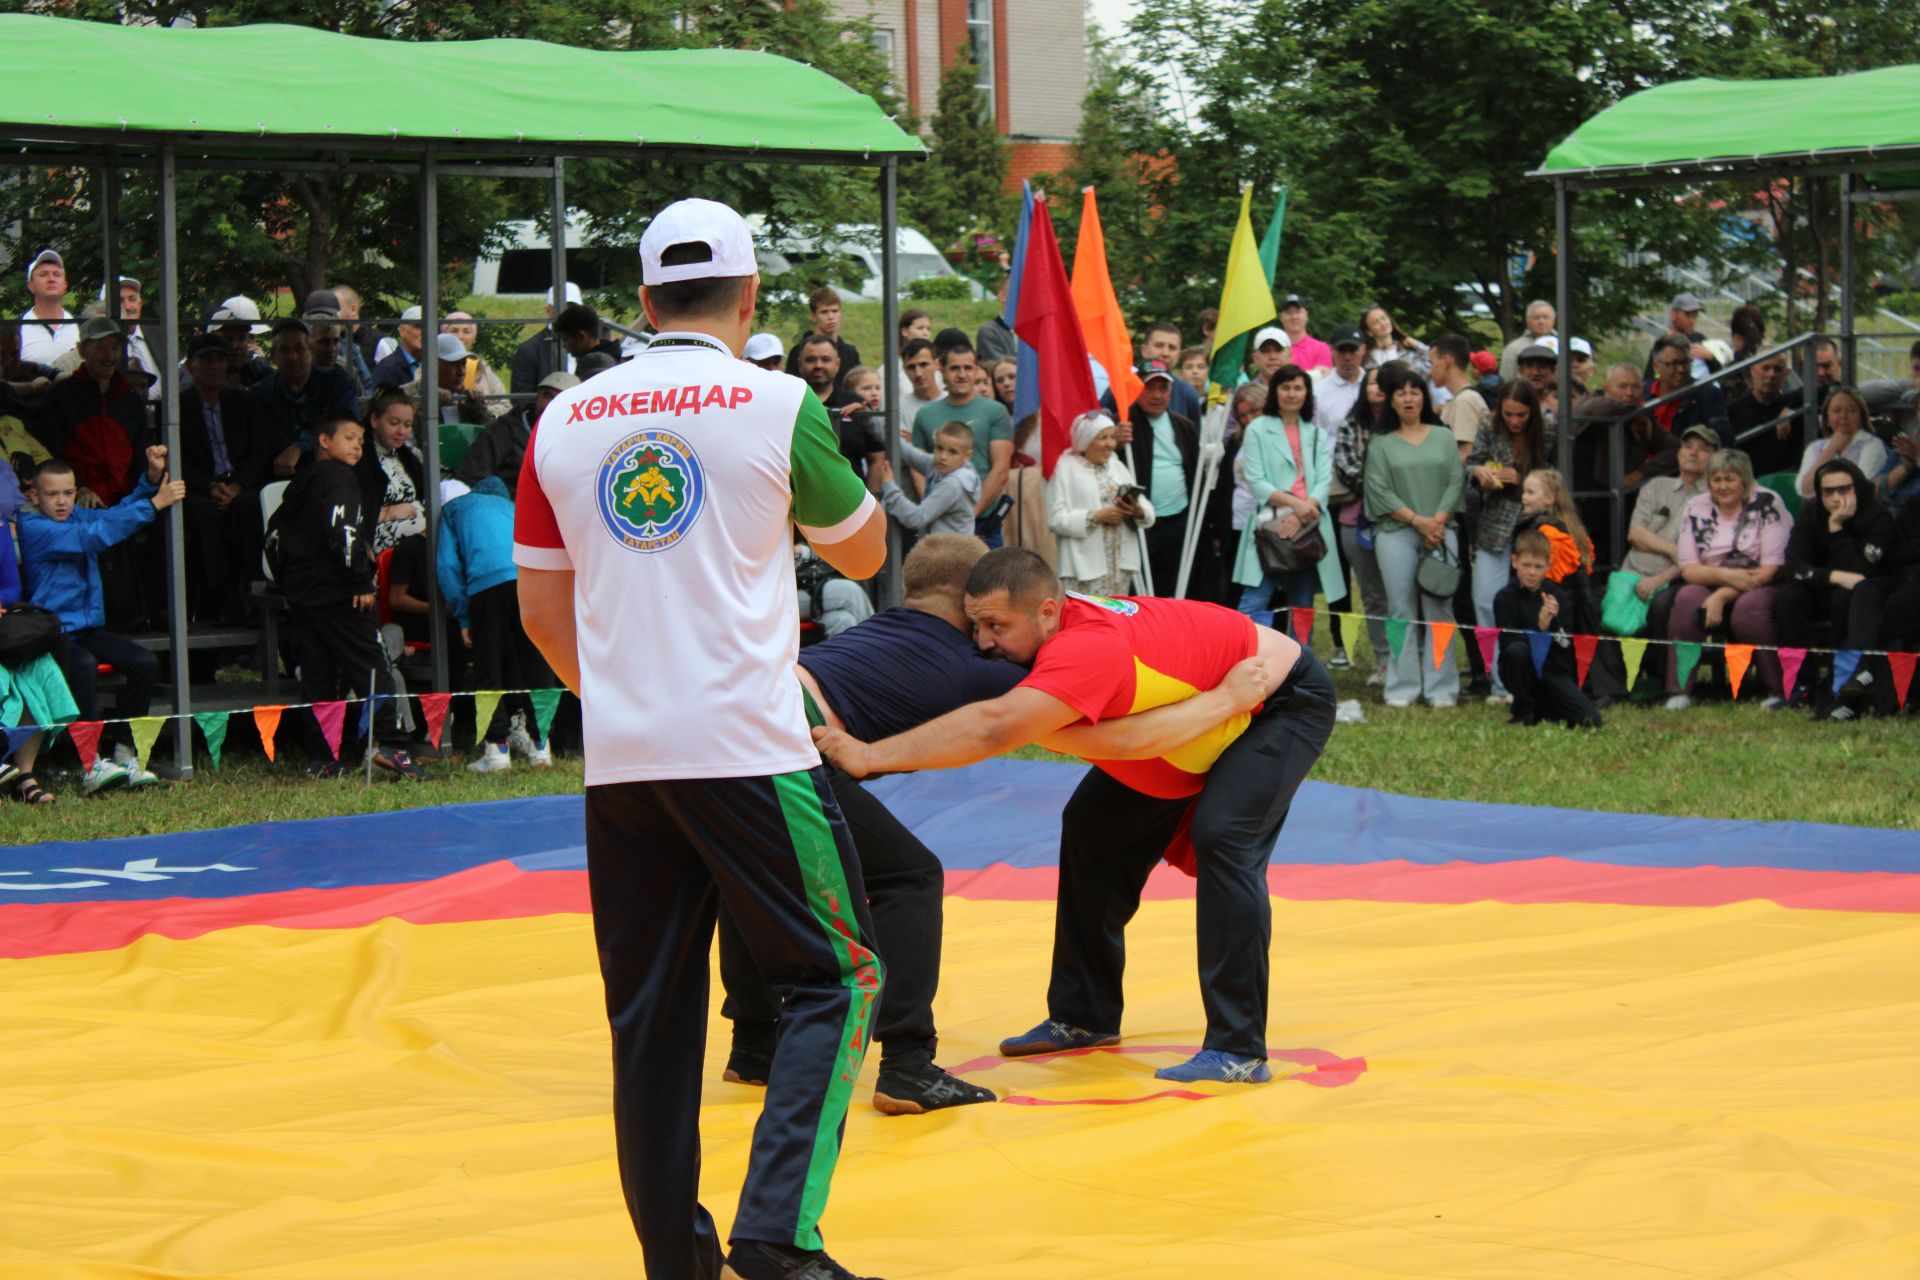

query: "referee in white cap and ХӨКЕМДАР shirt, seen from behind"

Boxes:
[513, 200, 887, 1280]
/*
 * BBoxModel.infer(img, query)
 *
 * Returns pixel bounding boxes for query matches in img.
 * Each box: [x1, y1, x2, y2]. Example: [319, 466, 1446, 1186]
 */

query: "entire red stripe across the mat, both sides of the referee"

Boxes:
[0, 858, 1920, 960]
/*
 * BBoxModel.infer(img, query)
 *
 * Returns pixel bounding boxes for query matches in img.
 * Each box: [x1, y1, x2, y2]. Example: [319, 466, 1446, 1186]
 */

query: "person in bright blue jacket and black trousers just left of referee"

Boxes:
[436, 476, 557, 773]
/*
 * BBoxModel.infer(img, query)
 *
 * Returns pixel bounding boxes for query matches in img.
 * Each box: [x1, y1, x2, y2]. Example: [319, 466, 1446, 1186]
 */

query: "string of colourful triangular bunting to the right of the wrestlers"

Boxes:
[1260, 606, 1920, 708]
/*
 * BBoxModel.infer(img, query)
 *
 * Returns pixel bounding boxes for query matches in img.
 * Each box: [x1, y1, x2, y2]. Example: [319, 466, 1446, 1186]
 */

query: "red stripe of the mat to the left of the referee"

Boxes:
[0, 862, 588, 960]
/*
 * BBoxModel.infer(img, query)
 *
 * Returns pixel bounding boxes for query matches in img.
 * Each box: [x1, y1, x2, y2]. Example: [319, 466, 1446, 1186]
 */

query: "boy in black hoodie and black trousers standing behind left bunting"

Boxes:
[267, 413, 426, 781]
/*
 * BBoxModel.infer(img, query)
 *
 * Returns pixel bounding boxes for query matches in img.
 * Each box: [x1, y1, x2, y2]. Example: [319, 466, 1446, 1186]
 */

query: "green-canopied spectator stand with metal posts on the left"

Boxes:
[0, 13, 925, 777]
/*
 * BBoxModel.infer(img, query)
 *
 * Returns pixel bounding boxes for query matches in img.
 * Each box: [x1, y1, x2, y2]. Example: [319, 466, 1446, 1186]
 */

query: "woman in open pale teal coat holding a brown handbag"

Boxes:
[1233, 365, 1346, 629]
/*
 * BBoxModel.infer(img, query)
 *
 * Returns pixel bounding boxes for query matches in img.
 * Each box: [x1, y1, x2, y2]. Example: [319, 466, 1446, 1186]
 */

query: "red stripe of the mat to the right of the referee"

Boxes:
[947, 858, 1920, 912]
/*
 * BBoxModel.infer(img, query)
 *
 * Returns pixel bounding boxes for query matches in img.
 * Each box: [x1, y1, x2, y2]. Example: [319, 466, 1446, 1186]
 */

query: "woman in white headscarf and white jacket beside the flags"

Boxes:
[1046, 411, 1154, 595]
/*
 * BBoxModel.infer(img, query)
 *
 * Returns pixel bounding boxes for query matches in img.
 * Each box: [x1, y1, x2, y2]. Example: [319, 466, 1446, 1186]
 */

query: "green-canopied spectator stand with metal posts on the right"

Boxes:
[1528, 65, 1920, 564]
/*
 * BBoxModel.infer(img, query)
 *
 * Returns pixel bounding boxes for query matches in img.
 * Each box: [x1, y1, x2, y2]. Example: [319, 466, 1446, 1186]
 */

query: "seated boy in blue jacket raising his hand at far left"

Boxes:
[19, 445, 186, 794]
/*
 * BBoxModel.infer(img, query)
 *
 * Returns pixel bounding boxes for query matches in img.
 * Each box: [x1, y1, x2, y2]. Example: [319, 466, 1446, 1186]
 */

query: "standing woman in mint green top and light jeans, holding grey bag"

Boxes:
[1367, 361, 1467, 708]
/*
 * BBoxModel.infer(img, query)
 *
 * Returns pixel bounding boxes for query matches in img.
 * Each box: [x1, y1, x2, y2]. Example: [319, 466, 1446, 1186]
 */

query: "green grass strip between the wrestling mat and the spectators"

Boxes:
[11, 620, 1920, 844]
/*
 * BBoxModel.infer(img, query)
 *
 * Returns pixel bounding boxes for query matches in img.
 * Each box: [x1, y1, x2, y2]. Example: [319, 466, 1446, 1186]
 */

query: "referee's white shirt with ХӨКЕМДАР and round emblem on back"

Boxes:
[513, 332, 874, 787]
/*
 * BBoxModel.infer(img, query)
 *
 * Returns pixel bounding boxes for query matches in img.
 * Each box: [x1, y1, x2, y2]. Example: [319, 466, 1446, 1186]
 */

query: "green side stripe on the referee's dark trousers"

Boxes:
[774, 773, 881, 1249]
